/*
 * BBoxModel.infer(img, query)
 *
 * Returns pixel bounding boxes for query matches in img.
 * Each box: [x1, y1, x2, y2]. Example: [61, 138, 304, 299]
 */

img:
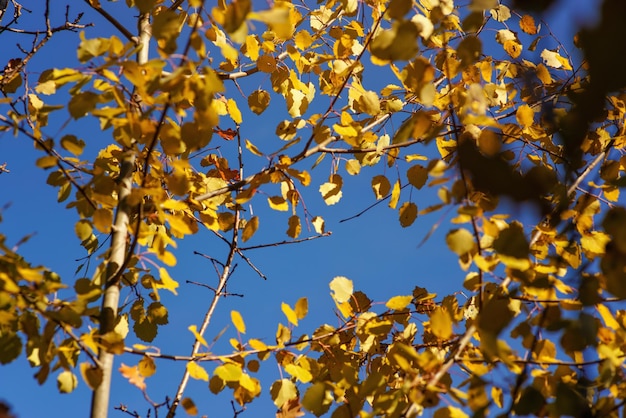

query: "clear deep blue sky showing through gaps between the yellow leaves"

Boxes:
[0, 0, 598, 418]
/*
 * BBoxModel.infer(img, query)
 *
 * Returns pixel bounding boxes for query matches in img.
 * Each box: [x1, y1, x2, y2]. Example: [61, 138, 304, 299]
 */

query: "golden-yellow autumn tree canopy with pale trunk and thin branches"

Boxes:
[0, 0, 626, 418]
